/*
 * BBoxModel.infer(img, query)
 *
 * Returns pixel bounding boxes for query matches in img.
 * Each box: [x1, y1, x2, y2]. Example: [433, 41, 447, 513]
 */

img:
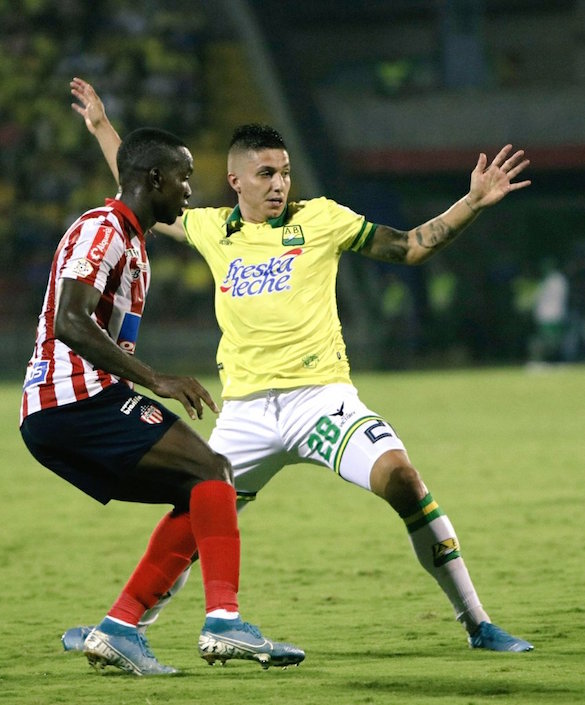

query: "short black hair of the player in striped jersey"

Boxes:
[116, 127, 186, 185]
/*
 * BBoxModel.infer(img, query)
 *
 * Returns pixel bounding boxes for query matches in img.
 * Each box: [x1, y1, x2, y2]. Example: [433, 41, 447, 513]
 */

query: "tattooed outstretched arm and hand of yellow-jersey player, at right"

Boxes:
[361, 144, 531, 264]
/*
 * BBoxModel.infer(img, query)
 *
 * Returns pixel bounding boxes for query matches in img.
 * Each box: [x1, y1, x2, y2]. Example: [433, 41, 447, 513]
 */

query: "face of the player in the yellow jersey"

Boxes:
[228, 149, 290, 223]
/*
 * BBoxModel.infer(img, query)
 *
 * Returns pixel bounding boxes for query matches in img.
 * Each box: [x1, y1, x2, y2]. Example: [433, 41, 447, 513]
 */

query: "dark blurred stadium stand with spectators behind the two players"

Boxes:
[0, 0, 585, 376]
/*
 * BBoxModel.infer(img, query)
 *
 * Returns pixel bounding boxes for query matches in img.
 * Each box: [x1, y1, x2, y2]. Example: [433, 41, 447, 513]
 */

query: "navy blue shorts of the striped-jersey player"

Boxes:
[20, 383, 179, 504]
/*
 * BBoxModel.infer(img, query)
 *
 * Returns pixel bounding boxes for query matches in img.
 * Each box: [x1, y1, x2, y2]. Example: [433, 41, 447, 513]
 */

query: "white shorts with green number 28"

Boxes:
[209, 384, 405, 492]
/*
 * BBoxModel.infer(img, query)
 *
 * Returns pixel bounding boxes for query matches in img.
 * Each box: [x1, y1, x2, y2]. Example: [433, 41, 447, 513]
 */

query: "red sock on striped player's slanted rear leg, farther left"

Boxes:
[108, 512, 197, 624]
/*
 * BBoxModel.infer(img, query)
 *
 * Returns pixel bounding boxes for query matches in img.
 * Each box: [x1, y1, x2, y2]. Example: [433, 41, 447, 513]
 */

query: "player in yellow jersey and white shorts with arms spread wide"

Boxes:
[63, 78, 533, 652]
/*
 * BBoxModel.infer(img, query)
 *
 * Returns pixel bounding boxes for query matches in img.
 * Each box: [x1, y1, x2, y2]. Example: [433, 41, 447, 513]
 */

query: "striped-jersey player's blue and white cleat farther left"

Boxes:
[82, 617, 178, 676]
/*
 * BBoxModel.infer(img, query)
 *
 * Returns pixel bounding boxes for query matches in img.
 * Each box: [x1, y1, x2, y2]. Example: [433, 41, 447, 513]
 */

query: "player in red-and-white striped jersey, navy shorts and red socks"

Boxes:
[20, 128, 304, 675]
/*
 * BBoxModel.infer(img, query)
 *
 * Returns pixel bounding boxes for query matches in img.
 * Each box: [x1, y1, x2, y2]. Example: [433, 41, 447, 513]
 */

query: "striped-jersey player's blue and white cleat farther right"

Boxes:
[199, 617, 305, 668]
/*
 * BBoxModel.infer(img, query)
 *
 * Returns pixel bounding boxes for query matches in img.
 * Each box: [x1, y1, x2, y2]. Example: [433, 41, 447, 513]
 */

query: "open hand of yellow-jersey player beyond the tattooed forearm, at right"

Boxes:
[468, 144, 531, 210]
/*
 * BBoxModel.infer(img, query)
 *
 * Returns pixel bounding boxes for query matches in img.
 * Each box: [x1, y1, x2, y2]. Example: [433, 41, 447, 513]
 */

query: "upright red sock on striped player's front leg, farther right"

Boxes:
[189, 480, 240, 612]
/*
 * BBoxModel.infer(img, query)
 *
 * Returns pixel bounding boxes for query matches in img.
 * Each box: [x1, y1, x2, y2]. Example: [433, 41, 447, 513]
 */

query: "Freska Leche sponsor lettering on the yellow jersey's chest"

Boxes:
[219, 247, 303, 299]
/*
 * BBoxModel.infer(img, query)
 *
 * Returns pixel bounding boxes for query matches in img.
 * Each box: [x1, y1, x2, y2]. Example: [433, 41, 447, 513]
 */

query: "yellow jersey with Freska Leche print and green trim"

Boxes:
[183, 197, 376, 399]
